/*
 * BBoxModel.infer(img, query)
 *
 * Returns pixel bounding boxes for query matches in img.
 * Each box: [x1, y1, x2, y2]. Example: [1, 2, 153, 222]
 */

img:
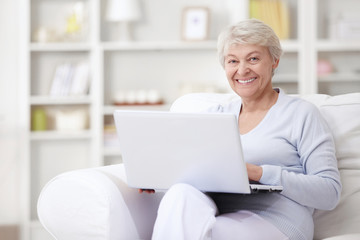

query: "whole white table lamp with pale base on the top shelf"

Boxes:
[105, 0, 140, 41]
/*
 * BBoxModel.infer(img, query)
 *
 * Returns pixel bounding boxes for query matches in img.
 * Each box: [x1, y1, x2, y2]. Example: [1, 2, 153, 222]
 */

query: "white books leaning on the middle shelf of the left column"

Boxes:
[50, 63, 89, 97]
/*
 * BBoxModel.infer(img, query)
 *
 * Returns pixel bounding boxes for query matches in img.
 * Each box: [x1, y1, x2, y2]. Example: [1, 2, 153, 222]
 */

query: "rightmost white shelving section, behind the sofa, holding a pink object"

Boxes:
[315, 0, 360, 95]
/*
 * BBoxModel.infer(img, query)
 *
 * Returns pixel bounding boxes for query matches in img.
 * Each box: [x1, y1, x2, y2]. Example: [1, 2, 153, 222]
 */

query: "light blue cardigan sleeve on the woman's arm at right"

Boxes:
[260, 103, 341, 210]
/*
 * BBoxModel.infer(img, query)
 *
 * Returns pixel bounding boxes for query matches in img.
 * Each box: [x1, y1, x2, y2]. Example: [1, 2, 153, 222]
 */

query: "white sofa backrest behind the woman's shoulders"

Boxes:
[170, 93, 360, 239]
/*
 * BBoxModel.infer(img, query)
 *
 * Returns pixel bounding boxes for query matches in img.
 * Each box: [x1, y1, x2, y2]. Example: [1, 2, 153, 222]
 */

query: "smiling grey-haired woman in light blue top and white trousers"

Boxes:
[146, 19, 341, 240]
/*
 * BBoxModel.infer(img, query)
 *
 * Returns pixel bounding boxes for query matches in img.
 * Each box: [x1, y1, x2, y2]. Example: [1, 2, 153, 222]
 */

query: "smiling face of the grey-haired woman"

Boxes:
[224, 44, 279, 99]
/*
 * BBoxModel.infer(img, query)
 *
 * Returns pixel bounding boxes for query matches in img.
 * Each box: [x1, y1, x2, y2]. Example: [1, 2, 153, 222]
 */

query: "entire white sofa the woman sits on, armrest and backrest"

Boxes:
[38, 93, 360, 240]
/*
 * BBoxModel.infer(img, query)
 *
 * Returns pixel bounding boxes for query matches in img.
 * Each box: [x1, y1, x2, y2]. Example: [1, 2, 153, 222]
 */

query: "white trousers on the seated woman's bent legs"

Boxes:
[152, 184, 288, 240]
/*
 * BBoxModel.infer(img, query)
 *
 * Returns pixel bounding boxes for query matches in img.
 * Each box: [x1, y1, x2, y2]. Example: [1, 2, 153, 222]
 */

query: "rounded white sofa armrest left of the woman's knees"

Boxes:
[38, 164, 162, 240]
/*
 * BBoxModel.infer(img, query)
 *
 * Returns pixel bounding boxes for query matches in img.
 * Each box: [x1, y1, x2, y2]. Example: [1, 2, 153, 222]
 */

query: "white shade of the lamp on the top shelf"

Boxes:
[105, 0, 140, 22]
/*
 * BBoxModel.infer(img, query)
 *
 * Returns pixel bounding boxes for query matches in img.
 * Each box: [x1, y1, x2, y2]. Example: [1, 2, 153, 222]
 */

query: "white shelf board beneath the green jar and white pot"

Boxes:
[30, 130, 91, 140]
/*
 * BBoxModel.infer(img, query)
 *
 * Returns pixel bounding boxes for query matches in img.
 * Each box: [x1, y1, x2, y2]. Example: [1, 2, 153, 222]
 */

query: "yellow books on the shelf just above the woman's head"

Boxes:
[250, 0, 290, 40]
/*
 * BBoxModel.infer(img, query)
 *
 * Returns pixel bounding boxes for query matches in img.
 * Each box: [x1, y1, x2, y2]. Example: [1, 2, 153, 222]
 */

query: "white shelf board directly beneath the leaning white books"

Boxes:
[30, 96, 91, 105]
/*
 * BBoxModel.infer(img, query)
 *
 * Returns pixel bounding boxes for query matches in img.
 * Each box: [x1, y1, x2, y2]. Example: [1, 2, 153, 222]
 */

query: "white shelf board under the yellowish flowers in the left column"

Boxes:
[30, 42, 91, 52]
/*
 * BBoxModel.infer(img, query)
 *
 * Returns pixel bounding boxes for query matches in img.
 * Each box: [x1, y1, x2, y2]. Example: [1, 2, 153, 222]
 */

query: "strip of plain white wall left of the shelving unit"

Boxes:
[0, 0, 21, 225]
